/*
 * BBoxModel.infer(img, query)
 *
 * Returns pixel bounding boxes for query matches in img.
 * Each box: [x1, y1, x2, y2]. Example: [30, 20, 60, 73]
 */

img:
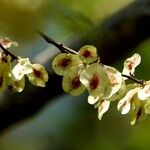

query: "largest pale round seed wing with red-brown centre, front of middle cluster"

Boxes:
[80, 63, 110, 97]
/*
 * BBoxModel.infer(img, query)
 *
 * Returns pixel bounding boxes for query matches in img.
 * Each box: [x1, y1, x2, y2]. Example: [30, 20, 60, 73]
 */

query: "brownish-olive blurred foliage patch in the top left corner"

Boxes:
[0, 0, 45, 38]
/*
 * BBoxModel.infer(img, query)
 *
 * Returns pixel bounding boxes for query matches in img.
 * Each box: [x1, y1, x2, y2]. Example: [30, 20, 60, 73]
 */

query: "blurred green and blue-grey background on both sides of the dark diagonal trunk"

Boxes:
[0, 0, 150, 150]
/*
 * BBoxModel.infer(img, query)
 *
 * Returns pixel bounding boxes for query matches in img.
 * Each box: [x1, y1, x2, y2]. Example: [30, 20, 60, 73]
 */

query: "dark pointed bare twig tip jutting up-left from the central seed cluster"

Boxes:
[37, 30, 78, 54]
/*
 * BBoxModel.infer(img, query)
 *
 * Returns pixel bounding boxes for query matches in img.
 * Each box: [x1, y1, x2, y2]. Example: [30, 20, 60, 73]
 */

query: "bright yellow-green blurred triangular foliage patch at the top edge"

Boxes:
[57, 0, 133, 22]
